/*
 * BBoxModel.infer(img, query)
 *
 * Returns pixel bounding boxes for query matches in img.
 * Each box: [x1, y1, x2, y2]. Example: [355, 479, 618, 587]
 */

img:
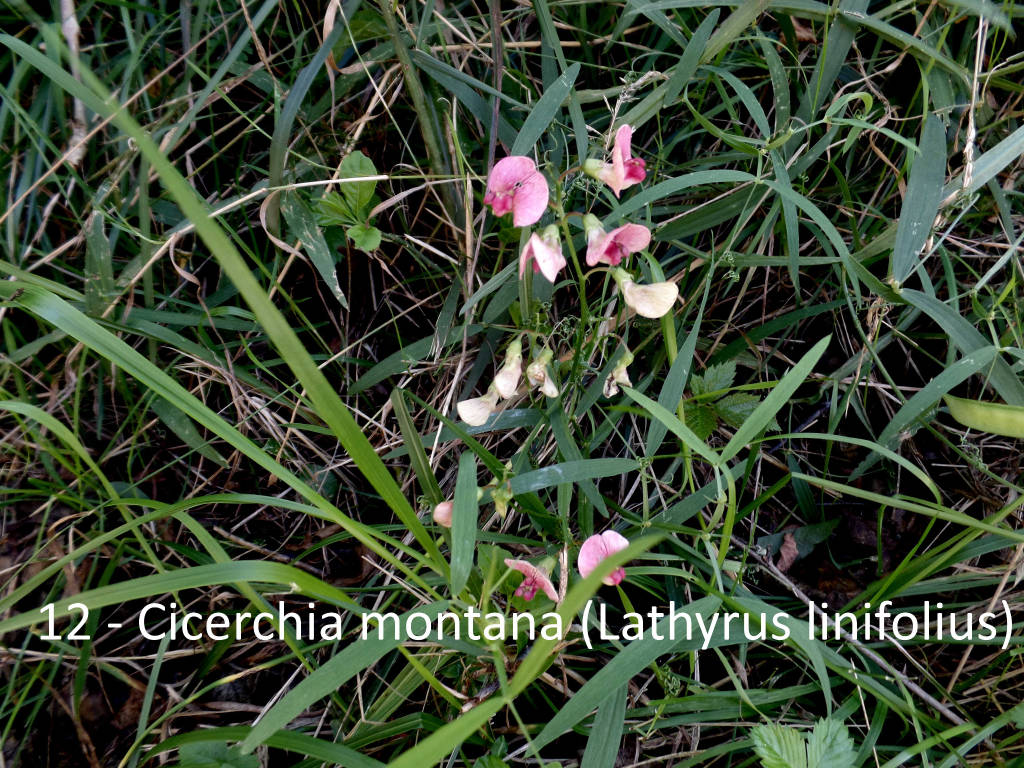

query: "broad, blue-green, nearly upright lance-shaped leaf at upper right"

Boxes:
[892, 115, 946, 284]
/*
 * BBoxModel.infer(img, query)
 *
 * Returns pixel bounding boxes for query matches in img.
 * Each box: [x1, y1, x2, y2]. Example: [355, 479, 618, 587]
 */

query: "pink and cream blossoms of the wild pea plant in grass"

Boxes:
[444, 125, 679, 602]
